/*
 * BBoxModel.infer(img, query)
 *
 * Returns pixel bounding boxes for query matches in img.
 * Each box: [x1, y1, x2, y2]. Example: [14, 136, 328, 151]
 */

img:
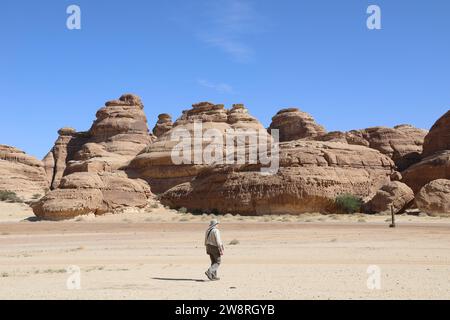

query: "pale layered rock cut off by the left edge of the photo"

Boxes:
[0, 145, 48, 200]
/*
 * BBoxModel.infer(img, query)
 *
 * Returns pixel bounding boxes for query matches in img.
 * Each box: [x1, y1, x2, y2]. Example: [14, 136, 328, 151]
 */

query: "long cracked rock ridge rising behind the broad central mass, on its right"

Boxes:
[317, 125, 427, 171]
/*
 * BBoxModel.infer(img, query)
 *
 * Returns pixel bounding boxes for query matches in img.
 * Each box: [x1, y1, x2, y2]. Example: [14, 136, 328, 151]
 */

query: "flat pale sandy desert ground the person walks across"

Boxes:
[0, 203, 450, 299]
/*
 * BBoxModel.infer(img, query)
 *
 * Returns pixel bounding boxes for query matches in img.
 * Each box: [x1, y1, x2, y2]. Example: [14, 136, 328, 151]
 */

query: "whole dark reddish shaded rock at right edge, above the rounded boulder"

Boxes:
[402, 111, 450, 193]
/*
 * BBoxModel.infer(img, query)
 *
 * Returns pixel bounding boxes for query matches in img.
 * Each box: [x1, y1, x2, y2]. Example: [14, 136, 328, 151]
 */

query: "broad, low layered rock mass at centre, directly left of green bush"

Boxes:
[161, 140, 394, 215]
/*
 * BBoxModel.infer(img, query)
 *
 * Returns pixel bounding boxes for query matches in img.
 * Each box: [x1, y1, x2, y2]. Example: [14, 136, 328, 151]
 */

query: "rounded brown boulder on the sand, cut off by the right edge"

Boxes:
[416, 179, 450, 216]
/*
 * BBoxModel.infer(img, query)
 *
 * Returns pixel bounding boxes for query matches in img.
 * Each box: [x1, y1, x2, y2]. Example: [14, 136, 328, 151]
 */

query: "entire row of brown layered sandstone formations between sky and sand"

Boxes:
[0, 94, 442, 220]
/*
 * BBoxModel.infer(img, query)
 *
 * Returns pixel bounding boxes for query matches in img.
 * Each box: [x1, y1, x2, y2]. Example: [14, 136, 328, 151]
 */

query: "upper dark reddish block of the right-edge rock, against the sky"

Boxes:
[423, 110, 450, 157]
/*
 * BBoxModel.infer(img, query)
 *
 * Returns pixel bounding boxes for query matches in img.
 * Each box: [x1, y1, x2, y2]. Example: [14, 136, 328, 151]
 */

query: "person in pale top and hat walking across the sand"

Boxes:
[205, 220, 223, 281]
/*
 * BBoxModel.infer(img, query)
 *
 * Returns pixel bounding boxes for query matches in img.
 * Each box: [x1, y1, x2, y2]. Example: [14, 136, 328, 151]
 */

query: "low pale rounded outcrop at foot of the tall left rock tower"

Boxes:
[33, 172, 152, 220]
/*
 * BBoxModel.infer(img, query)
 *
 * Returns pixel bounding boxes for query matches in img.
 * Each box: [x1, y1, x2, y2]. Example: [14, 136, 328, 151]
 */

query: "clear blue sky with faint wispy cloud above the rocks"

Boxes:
[0, 0, 450, 158]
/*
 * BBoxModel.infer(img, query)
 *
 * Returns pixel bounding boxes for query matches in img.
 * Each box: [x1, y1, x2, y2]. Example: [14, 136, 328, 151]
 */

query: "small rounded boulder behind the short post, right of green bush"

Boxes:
[366, 181, 414, 214]
